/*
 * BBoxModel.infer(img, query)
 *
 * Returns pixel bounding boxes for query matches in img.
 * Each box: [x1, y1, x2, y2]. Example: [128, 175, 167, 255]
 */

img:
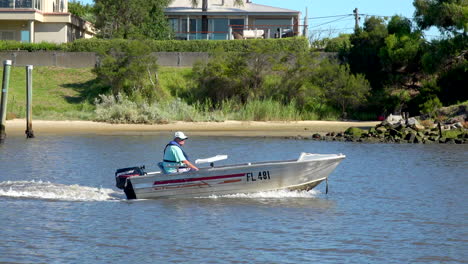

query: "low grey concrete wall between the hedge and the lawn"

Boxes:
[0, 51, 209, 68]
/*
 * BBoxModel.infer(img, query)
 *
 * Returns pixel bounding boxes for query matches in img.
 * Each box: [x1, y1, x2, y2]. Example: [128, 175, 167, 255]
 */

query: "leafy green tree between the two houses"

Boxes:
[94, 0, 171, 39]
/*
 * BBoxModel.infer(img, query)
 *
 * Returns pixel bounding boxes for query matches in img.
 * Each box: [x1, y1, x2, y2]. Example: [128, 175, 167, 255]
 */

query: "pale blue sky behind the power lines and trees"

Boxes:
[80, 0, 439, 39]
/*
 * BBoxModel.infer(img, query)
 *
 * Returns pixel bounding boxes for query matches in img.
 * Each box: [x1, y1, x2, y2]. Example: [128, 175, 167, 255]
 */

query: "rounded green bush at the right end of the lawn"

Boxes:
[94, 41, 165, 101]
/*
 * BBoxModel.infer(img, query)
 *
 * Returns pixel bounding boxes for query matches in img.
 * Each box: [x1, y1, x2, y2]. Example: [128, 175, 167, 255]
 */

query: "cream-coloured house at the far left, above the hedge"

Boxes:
[0, 0, 95, 43]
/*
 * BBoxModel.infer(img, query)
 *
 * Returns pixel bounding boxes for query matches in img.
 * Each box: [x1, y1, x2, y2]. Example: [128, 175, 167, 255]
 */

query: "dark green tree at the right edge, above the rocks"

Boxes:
[413, 0, 468, 105]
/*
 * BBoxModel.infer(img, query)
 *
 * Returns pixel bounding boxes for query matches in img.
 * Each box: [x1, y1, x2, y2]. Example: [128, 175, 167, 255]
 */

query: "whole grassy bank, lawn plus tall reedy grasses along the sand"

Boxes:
[0, 67, 328, 123]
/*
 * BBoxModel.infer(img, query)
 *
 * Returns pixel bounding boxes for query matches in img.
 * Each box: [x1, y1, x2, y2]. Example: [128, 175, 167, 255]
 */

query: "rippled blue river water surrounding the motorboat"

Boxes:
[0, 133, 468, 263]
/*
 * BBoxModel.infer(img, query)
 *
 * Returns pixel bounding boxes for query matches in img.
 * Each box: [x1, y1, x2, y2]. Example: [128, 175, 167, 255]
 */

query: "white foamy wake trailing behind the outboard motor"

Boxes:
[0, 181, 124, 201]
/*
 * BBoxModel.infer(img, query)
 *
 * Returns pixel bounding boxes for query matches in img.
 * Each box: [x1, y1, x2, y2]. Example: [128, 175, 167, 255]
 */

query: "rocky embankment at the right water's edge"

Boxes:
[312, 111, 468, 144]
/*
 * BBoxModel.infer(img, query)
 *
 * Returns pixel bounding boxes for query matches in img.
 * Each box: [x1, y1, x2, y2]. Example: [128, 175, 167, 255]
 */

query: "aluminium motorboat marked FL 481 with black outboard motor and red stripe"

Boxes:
[115, 153, 345, 199]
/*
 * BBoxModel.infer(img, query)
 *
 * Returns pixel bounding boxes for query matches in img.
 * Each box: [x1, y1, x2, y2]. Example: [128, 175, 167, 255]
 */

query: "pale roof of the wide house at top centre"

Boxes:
[165, 0, 300, 15]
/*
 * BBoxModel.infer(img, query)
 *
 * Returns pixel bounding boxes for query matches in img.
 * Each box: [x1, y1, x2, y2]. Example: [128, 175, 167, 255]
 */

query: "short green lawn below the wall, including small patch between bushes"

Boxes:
[0, 66, 191, 120]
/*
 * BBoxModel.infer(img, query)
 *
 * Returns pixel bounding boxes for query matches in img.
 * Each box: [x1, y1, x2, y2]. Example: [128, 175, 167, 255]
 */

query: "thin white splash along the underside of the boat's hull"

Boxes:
[200, 190, 320, 199]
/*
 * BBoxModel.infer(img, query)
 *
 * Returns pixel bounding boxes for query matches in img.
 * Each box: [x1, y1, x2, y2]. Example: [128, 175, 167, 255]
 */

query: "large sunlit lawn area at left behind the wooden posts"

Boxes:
[0, 67, 95, 120]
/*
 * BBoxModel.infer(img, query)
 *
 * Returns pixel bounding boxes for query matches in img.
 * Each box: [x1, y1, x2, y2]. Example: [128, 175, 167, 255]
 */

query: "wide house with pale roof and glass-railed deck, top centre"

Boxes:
[165, 0, 300, 40]
